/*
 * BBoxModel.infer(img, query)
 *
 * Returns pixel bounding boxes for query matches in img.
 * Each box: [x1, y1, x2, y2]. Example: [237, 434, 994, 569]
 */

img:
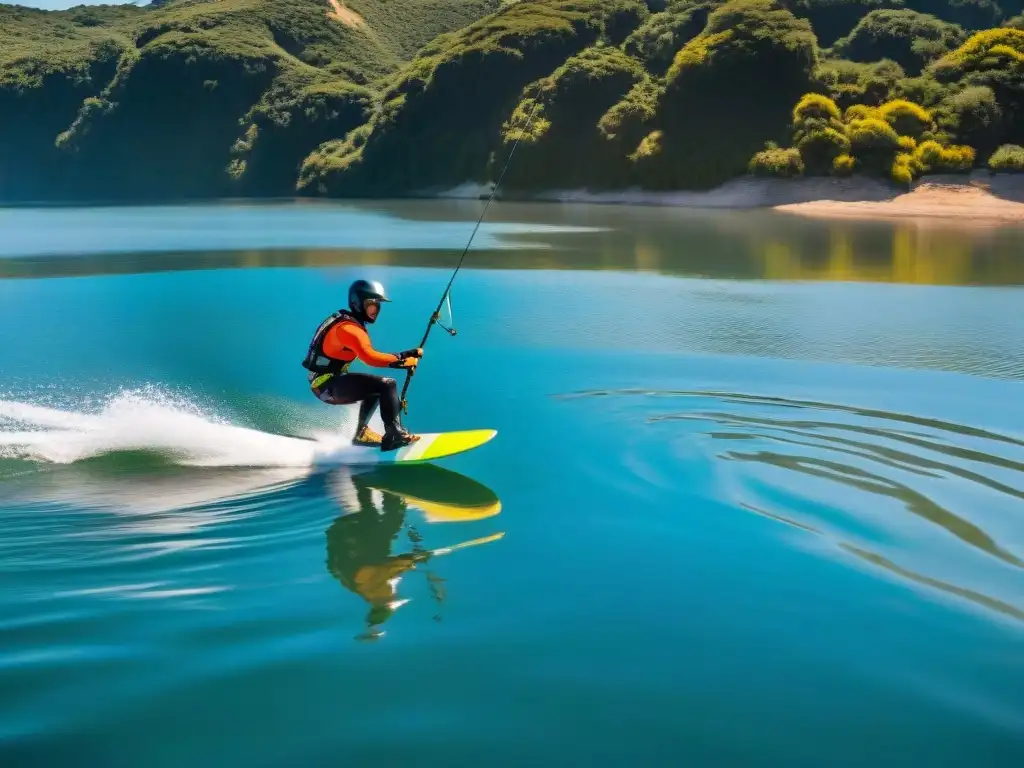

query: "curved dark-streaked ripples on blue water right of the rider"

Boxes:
[562, 389, 1024, 622]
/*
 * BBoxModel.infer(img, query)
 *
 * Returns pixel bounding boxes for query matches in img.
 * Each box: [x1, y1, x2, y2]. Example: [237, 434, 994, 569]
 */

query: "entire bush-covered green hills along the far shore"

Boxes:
[0, 0, 1024, 200]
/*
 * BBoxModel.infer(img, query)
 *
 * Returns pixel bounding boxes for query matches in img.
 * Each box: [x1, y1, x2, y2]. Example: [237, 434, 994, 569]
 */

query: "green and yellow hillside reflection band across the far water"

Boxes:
[6, 203, 1024, 286]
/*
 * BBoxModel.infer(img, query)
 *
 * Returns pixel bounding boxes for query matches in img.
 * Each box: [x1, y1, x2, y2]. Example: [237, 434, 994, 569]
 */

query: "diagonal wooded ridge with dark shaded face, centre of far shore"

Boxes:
[300, 0, 646, 196]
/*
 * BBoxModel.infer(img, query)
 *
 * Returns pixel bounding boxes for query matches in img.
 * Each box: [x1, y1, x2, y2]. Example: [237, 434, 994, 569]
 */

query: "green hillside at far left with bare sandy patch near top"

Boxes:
[0, 0, 498, 200]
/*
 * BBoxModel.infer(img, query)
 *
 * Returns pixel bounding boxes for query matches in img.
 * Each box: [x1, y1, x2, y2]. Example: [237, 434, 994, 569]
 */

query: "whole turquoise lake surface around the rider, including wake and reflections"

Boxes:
[0, 202, 1024, 768]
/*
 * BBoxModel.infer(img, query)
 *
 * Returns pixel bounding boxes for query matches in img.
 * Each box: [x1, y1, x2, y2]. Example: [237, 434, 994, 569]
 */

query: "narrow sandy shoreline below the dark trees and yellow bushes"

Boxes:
[428, 171, 1024, 225]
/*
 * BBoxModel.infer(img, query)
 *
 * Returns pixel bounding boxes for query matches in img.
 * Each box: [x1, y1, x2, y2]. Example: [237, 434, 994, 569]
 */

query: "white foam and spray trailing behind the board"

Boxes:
[0, 388, 357, 467]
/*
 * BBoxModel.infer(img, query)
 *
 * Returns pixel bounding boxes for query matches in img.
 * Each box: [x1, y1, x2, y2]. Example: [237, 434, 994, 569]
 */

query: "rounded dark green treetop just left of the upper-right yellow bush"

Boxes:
[833, 10, 967, 75]
